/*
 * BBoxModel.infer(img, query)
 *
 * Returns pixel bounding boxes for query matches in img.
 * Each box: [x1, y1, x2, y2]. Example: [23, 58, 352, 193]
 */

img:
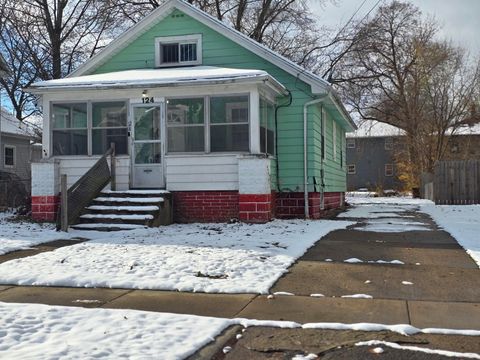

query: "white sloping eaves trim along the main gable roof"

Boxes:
[68, 0, 330, 94]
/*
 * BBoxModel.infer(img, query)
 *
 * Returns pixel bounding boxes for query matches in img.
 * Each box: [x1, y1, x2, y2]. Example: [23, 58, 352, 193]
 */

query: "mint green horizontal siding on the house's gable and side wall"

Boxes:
[94, 10, 346, 191]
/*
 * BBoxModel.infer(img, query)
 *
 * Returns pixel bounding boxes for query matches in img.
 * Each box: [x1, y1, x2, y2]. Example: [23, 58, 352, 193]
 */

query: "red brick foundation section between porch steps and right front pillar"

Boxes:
[172, 191, 238, 223]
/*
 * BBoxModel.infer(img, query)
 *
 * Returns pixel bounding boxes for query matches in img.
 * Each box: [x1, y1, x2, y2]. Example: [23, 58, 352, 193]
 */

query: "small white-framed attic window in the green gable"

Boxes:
[155, 34, 202, 67]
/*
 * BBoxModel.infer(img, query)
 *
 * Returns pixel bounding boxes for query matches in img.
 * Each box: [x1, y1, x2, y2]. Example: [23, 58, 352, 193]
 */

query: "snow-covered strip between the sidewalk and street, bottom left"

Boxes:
[0, 303, 231, 360]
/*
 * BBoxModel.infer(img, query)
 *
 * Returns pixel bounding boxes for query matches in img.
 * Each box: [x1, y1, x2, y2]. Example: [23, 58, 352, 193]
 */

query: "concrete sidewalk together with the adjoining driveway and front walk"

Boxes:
[0, 205, 480, 330]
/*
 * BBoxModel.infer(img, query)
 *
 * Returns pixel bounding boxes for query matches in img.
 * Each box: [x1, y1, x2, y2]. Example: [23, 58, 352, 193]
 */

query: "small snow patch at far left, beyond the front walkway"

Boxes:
[0, 212, 76, 255]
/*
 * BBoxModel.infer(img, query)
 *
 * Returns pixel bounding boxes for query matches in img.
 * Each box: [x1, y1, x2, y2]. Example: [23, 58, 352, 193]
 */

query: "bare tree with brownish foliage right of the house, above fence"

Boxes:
[338, 1, 480, 188]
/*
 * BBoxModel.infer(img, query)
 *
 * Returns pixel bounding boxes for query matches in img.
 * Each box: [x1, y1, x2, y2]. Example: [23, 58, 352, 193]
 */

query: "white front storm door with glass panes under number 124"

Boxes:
[131, 104, 165, 188]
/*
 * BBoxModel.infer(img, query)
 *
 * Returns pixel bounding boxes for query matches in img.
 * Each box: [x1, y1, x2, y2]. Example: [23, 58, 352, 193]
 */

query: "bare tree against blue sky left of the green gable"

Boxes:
[0, 0, 119, 120]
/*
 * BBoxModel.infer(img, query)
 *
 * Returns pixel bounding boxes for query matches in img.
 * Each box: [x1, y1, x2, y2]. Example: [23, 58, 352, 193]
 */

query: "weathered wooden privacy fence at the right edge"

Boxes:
[432, 160, 480, 205]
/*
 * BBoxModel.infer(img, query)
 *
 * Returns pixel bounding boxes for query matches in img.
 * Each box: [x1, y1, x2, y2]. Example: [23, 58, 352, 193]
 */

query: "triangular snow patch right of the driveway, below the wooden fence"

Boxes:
[421, 205, 480, 267]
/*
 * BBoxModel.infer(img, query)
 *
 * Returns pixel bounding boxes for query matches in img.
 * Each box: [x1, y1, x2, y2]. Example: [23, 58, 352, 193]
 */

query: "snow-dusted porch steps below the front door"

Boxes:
[71, 190, 172, 231]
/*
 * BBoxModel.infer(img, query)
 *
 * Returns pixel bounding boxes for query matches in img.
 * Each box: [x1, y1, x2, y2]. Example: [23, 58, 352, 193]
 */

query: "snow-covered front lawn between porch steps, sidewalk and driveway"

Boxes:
[0, 220, 354, 293]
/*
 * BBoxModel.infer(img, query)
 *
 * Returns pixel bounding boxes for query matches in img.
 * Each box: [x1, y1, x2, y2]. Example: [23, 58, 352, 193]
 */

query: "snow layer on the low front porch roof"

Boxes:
[31, 66, 284, 89]
